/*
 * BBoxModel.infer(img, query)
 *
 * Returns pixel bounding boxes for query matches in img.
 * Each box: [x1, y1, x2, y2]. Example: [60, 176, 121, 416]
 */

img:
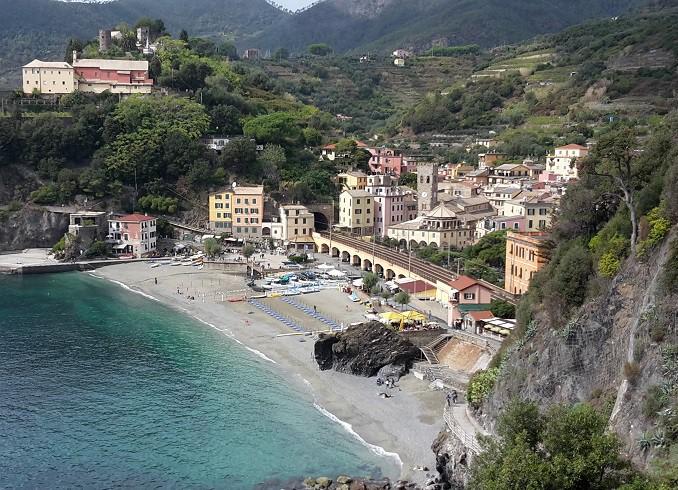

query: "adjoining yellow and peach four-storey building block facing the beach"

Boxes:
[209, 186, 264, 238]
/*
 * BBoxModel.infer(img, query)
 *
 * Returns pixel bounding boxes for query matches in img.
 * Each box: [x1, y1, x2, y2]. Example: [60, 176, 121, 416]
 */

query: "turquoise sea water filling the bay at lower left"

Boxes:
[0, 273, 394, 489]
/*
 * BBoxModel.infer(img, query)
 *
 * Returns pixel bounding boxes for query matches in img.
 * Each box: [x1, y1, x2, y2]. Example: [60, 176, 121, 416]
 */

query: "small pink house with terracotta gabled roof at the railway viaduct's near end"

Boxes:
[447, 276, 493, 331]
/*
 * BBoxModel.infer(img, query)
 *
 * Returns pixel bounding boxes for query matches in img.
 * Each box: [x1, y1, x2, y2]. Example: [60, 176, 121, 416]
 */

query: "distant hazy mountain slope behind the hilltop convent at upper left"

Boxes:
[0, 0, 288, 88]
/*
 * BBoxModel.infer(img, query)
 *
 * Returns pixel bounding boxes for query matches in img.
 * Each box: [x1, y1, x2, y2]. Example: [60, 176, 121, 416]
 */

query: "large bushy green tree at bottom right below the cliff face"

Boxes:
[469, 400, 633, 490]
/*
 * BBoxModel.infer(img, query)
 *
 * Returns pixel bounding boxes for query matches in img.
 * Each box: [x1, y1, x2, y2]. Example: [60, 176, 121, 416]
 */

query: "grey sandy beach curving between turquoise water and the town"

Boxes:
[95, 263, 444, 483]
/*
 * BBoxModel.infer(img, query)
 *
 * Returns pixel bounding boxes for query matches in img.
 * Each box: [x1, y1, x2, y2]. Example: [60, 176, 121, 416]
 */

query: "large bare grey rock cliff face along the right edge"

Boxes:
[480, 229, 678, 467]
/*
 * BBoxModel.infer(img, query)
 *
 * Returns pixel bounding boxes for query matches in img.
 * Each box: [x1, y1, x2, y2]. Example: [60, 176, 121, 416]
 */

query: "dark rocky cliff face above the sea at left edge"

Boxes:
[0, 206, 68, 251]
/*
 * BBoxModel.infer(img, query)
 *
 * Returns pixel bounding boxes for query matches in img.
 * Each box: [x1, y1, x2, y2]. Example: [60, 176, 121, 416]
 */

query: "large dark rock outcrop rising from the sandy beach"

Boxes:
[314, 322, 420, 378]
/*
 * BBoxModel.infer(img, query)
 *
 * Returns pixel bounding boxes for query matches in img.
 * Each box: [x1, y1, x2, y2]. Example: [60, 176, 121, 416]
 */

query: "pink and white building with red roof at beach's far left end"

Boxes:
[107, 214, 157, 257]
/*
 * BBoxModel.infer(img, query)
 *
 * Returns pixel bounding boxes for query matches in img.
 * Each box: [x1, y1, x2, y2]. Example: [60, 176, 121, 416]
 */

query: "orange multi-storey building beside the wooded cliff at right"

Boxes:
[504, 231, 549, 294]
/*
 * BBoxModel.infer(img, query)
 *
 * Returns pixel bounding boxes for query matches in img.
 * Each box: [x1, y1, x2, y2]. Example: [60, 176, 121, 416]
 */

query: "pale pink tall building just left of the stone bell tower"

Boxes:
[365, 175, 417, 237]
